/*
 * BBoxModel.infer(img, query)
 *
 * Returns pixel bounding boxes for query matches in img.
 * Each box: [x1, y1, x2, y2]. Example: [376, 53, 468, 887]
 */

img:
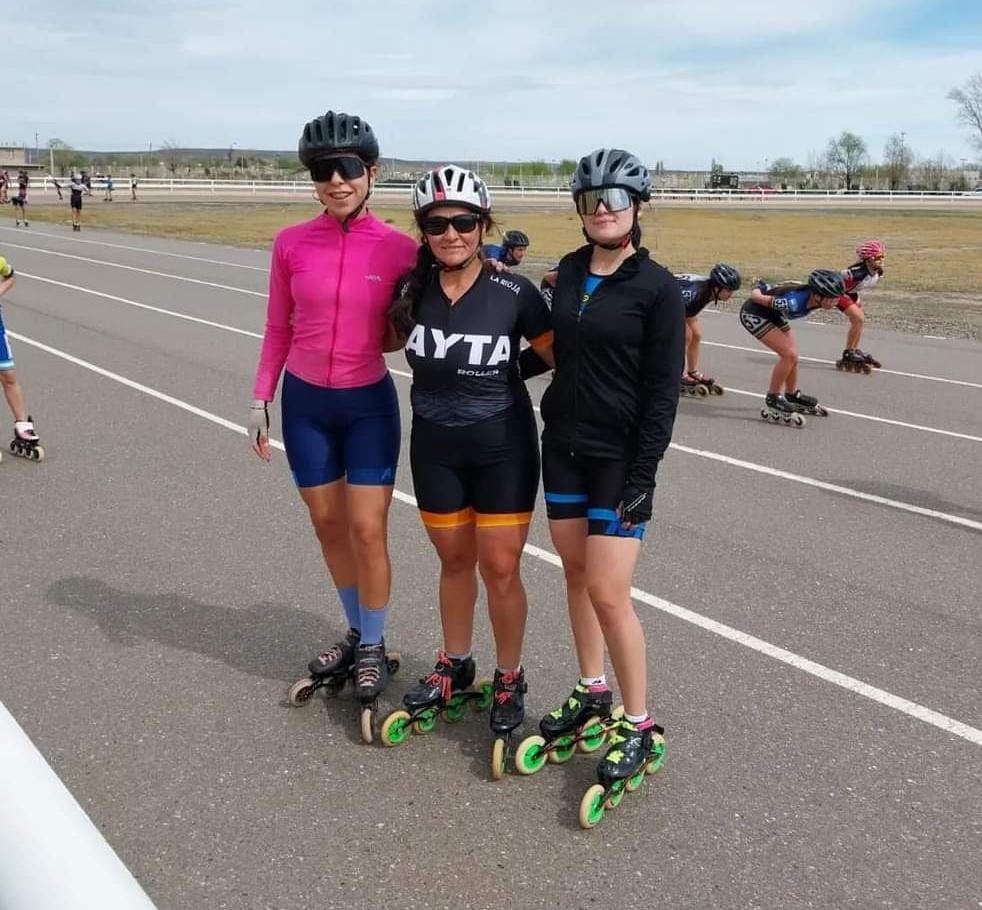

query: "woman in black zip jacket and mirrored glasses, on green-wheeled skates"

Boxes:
[516, 149, 685, 827]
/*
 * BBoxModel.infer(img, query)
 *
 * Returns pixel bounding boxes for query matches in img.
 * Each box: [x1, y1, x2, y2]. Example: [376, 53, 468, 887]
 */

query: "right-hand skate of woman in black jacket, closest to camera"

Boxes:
[580, 719, 665, 828]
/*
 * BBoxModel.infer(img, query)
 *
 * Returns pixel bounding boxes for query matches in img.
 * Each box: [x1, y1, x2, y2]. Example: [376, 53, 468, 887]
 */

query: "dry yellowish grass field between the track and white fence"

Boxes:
[17, 197, 982, 338]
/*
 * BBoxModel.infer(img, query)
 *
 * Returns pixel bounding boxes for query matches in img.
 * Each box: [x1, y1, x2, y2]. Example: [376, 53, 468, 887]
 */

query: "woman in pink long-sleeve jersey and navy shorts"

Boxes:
[249, 111, 416, 741]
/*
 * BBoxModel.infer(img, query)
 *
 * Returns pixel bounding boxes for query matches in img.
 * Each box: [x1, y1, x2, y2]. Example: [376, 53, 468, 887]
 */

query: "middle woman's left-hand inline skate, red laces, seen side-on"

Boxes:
[380, 651, 494, 746]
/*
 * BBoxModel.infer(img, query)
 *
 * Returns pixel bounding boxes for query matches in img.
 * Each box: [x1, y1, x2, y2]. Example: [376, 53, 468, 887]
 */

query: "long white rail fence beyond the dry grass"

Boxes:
[31, 177, 982, 204]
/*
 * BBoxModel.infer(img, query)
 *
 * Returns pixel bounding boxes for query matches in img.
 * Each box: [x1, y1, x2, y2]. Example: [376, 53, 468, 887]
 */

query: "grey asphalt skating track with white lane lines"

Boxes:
[0, 225, 982, 910]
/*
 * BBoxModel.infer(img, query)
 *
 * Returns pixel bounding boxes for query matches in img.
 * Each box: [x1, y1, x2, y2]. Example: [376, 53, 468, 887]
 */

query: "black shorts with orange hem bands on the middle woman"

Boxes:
[410, 398, 539, 529]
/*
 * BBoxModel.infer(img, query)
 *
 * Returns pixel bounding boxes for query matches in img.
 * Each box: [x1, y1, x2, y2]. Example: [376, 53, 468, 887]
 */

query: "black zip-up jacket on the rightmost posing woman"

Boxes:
[542, 246, 685, 489]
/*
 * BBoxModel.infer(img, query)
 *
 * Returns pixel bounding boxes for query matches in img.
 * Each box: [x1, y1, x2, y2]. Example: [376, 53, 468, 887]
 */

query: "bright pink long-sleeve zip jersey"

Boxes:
[253, 212, 417, 401]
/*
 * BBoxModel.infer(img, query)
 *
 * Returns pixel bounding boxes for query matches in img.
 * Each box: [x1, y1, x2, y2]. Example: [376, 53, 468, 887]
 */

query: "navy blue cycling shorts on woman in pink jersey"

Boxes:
[283, 372, 402, 487]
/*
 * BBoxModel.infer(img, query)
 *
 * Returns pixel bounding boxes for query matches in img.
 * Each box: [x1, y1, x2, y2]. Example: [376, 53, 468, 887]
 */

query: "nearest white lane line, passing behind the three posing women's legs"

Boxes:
[9, 332, 982, 746]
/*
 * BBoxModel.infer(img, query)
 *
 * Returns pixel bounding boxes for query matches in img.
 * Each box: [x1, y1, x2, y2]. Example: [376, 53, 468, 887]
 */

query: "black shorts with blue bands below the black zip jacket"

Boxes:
[542, 445, 645, 539]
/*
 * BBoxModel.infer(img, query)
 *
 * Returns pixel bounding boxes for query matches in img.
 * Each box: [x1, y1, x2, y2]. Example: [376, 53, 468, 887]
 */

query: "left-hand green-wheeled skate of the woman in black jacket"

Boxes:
[515, 683, 624, 775]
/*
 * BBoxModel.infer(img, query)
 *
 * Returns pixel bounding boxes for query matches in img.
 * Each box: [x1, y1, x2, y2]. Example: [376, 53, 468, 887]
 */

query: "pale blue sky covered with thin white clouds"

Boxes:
[0, 0, 982, 169]
